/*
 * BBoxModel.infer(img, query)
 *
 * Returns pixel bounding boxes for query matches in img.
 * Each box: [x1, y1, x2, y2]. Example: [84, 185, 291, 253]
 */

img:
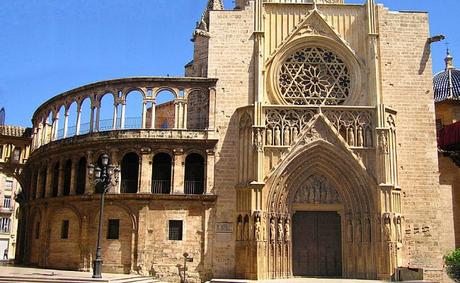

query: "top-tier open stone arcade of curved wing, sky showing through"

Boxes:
[32, 77, 217, 150]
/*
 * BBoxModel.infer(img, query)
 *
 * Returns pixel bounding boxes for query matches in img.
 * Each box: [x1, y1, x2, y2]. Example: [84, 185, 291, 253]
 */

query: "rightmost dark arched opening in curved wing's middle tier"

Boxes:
[184, 153, 204, 194]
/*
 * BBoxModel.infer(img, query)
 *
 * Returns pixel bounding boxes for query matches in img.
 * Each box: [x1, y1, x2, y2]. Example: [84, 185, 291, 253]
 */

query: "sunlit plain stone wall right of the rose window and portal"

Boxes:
[378, 6, 454, 281]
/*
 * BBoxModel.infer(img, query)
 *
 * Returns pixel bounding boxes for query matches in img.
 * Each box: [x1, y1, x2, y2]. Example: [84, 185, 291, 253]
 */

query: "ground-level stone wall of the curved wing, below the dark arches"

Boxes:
[27, 195, 216, 282]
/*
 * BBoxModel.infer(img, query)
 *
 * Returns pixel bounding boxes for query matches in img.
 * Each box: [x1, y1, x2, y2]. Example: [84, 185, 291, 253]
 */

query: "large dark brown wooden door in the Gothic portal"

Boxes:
[292, 212, 342, 277]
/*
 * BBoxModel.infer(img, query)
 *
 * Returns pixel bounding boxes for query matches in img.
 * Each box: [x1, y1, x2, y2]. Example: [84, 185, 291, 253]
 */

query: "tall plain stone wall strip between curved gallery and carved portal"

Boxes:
[208, 2, 254, 278]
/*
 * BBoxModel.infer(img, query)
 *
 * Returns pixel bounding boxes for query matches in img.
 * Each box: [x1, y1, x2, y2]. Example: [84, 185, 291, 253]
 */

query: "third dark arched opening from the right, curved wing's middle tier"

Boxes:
[121, 152, 139, 194]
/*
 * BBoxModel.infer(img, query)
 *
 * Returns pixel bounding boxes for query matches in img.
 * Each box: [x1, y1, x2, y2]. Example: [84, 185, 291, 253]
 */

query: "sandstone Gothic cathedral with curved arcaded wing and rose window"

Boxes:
[9, 0, 454, 282]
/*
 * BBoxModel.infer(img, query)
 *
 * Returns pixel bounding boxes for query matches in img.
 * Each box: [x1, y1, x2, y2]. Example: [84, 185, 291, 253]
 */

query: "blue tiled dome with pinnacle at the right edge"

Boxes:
[433, 51, 460, 102]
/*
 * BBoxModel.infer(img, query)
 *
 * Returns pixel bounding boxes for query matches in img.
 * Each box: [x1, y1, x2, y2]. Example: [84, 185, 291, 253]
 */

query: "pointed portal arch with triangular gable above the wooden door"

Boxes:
[266, 114, 377, 216]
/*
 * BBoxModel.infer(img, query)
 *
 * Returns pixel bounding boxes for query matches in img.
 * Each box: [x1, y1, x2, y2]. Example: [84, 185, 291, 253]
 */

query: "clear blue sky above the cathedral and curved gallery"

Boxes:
[0, 0, 460, 126]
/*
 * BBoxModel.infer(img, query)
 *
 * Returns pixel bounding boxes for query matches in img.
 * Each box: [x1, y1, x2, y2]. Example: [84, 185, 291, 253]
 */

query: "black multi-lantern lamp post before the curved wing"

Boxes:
[88, 154, 120, 278]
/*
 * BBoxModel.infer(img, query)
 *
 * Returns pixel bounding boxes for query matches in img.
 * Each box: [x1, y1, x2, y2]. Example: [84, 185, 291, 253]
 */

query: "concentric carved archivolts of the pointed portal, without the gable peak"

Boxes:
[266, 140, 377, 216]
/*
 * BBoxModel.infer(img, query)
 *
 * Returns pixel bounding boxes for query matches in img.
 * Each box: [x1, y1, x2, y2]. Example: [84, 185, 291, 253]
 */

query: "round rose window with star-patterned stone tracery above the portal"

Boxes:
[279, 47, 351, 105]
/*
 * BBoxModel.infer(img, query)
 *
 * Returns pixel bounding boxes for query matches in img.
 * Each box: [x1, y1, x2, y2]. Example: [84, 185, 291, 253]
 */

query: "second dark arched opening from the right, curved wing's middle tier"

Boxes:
[152, 153, 172, 194]
